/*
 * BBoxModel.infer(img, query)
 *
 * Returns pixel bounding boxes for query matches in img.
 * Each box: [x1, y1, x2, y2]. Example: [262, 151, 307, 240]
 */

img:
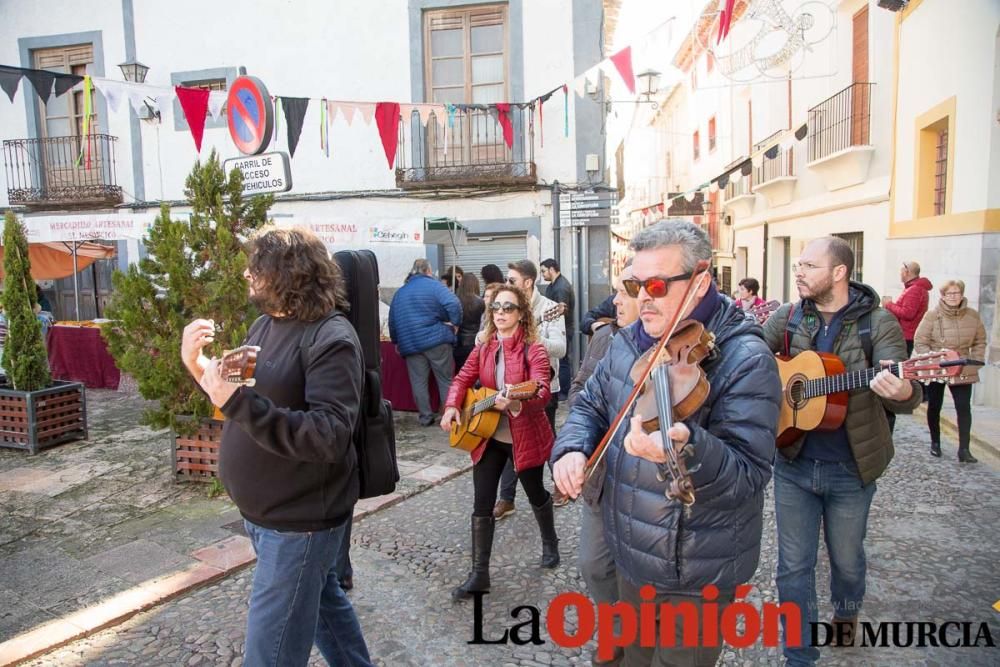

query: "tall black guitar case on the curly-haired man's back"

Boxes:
[333, 250, 399, 498]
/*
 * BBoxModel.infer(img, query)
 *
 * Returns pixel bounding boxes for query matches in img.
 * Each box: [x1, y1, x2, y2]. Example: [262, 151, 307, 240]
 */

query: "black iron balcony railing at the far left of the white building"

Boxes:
[3, 134, 122, 207]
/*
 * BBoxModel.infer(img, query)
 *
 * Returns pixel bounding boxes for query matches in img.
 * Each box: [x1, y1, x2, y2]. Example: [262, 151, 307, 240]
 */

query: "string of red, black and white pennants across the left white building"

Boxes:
[0, 40, 635, 169]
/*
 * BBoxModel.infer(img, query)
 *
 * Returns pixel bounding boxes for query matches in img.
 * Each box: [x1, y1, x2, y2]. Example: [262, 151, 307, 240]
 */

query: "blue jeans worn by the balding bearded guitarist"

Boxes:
[774, 454, 875, 665]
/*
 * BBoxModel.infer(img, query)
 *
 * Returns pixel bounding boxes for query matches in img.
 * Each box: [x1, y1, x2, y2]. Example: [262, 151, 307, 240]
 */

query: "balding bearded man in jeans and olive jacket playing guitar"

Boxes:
[764, 236, 921, 666]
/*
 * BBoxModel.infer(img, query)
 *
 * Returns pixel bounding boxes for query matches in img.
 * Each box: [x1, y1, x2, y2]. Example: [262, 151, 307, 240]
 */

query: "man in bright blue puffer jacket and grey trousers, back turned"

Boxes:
[389, 259, 462, 426]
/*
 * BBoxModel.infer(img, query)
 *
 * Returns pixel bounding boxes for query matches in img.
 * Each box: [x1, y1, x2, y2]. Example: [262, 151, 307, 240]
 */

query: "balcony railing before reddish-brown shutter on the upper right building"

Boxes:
[808, 83, 875, 162]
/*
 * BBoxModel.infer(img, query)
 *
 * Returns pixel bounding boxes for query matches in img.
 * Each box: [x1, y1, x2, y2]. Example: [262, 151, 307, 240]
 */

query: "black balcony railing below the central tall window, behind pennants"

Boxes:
[396, 105, 538, 189]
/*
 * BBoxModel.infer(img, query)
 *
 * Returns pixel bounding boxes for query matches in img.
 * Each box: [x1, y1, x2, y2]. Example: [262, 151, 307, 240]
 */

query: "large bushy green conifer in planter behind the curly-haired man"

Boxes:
[102, 151, 274, 434]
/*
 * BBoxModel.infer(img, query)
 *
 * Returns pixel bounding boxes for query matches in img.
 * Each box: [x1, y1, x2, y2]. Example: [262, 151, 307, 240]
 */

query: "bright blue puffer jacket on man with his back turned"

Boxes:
[389, 273, 462, 357]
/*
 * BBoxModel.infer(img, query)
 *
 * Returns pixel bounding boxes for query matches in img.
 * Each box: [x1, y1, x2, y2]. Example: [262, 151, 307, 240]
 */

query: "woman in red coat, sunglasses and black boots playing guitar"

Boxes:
[441, 286, 559, 600]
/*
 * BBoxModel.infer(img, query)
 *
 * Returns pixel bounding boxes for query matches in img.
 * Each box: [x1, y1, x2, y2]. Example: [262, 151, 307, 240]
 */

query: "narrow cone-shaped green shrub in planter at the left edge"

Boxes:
[0, 211, 52, 391]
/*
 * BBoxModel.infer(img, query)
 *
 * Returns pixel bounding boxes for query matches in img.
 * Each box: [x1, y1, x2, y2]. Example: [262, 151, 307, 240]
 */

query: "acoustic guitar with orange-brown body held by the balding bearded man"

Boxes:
[776, 350, 968, 447]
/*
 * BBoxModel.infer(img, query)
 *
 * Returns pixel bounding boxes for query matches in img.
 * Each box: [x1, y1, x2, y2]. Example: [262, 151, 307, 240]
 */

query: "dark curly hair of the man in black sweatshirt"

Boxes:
[247, 227, 350, 322]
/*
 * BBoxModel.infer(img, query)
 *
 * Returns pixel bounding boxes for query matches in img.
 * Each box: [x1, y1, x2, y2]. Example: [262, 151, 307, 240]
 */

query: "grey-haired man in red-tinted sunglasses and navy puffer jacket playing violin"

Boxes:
[551, 220, 781, 665]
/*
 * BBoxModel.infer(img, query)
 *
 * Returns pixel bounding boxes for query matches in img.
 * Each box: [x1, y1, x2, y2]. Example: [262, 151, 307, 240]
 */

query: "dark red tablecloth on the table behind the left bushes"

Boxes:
[46, 324, 121, 389]
